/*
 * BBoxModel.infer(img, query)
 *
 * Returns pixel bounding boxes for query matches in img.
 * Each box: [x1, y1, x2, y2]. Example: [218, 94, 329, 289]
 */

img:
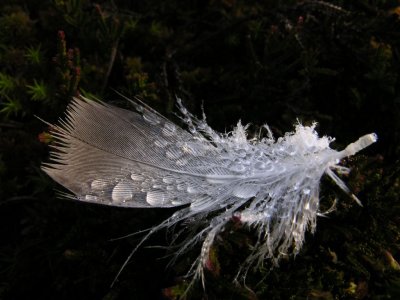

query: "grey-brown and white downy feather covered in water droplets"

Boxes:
[42, 97, 377, 286]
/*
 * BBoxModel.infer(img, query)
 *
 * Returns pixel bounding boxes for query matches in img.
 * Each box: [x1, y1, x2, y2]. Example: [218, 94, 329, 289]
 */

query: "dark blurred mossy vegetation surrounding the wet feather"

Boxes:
[0, 0, 400, 299]
